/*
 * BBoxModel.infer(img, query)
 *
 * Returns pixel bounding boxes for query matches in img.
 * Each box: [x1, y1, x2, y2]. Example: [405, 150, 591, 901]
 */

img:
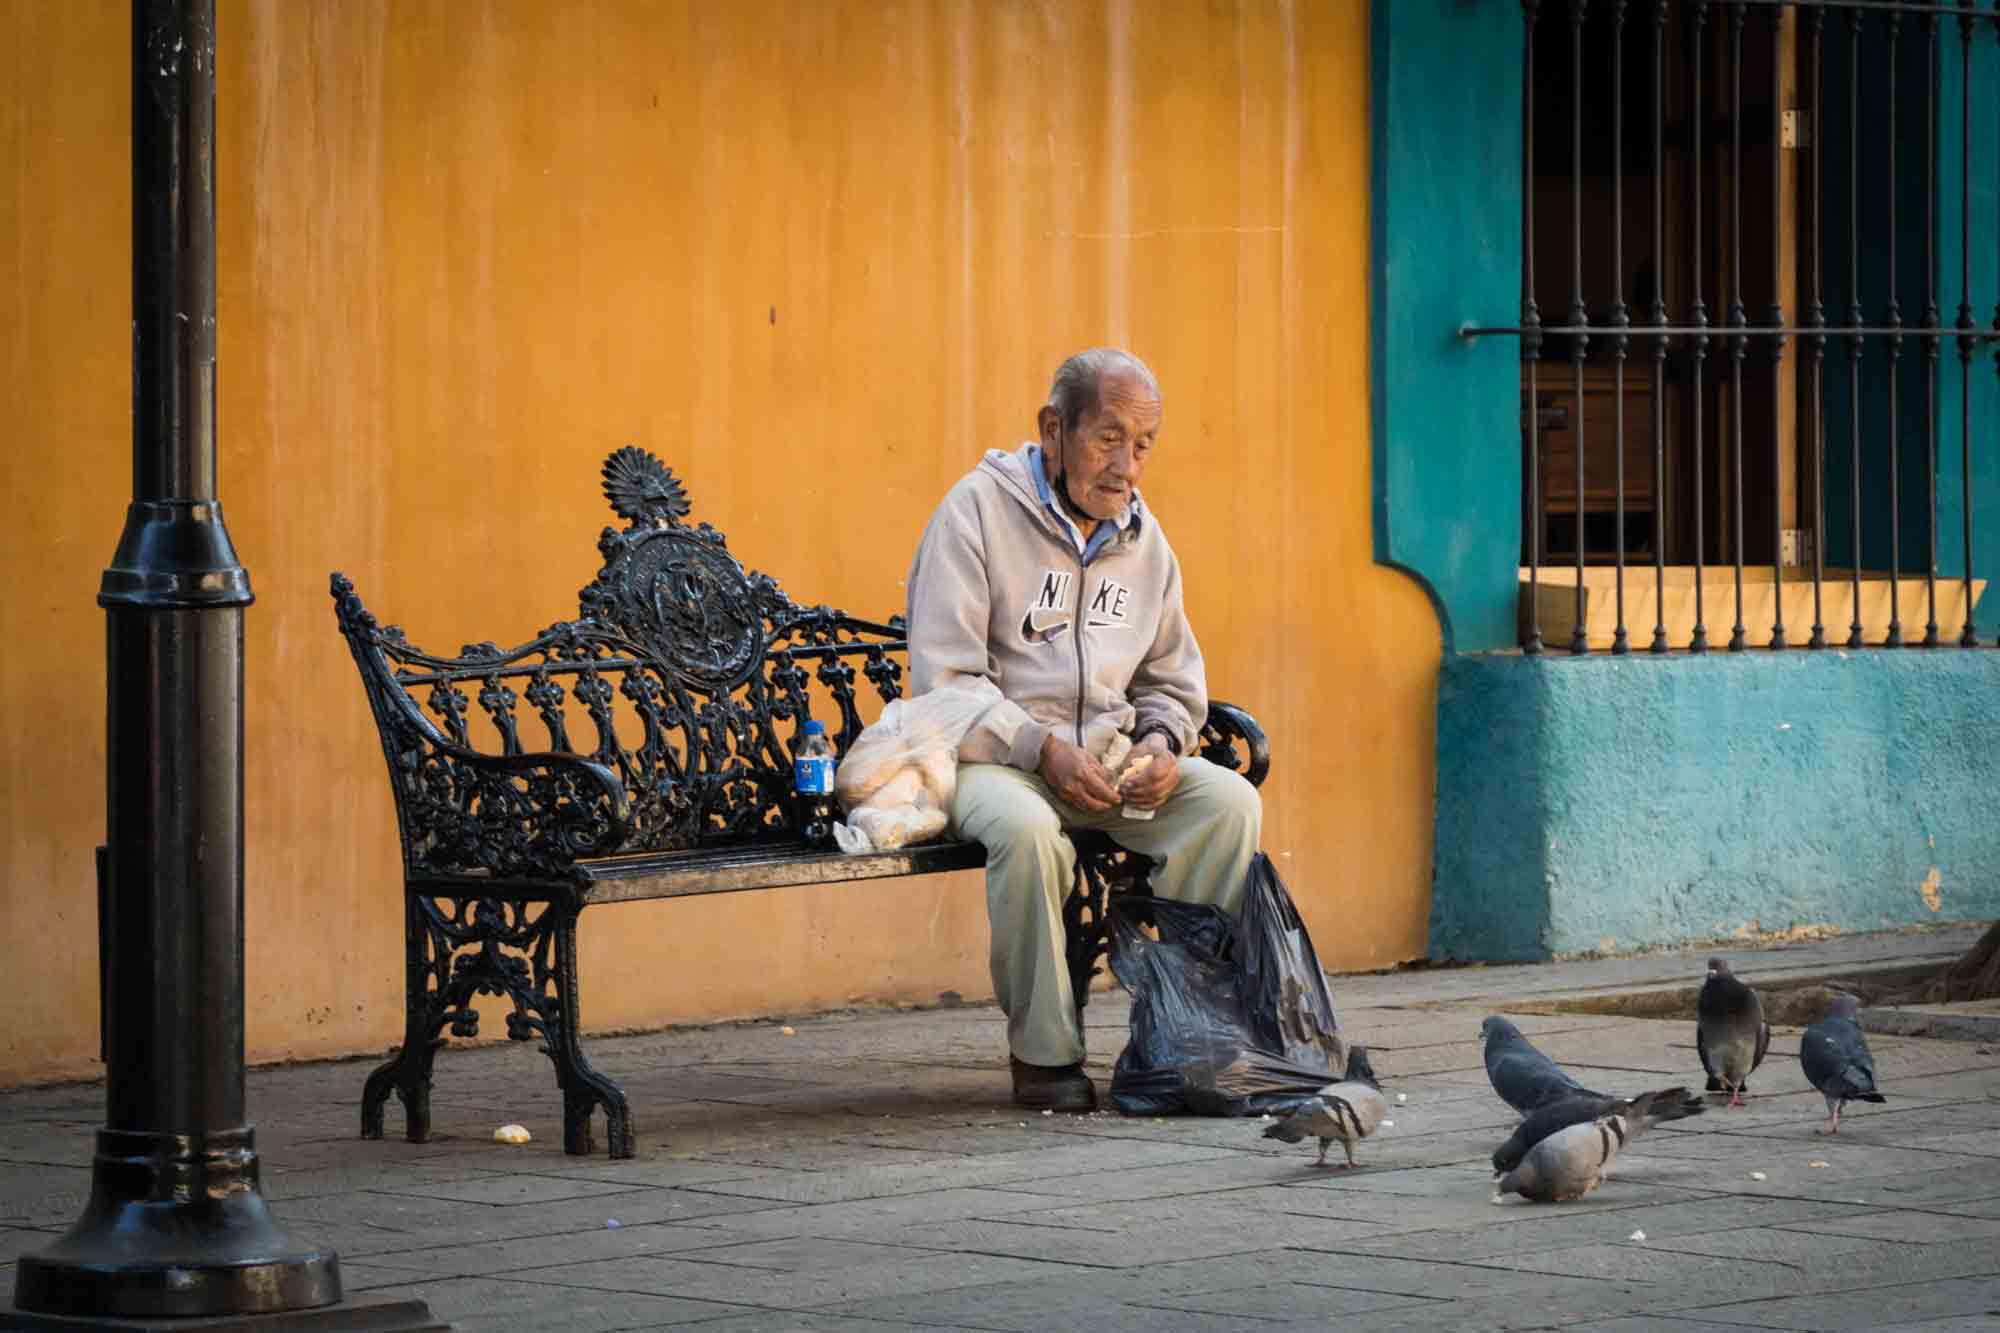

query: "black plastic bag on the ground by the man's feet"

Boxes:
[1110, 853, 1346, 1115]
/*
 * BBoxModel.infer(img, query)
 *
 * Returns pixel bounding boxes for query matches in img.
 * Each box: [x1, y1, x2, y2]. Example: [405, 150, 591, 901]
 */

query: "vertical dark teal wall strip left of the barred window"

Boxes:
[1370, 0, 1522, 652]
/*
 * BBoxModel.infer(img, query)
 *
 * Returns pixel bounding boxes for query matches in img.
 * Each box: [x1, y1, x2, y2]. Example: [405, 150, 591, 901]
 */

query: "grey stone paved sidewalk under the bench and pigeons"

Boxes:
[0, 929, 2000, 1333]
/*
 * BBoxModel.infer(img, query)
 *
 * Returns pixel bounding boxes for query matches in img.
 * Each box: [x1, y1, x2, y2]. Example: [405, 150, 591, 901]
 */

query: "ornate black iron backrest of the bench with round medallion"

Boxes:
[332, 448, 908, 875]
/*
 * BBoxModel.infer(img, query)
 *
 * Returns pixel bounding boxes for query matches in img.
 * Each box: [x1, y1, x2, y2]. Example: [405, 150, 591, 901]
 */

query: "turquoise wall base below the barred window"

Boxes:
[1430, 648, 2000, 961]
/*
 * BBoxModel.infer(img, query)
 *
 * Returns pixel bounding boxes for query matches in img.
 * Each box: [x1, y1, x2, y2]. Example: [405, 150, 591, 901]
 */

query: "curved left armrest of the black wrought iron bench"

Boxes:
[402, 737, 632, 879]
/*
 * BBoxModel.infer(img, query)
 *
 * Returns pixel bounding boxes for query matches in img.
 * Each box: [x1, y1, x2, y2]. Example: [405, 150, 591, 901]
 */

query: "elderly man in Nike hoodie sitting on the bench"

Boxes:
[910, 348, 1262, 1111]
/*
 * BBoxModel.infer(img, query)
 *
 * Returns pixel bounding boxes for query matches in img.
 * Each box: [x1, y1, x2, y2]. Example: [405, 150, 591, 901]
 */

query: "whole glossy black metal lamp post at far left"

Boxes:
[0, 0, 438, 1327]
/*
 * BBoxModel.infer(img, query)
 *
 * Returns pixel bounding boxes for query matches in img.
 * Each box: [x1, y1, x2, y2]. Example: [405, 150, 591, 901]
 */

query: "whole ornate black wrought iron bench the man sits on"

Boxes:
[332, 448, 1270, 1157]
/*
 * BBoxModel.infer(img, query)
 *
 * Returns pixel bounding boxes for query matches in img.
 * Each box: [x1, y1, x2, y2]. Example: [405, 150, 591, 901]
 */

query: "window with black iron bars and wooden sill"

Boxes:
[1466, 0, 2000, 652]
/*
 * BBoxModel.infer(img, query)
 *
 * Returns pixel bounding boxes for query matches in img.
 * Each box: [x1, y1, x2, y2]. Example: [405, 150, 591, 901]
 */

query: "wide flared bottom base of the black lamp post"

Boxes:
[0, 1127, 340, 1327]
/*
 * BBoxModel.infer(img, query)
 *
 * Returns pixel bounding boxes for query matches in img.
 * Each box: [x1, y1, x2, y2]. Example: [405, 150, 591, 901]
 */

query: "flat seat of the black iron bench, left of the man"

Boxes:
[576, 843, 986, 903]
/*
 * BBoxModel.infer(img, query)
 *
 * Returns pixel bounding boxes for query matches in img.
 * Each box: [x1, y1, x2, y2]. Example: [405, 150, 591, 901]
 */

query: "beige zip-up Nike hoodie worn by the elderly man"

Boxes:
[910, 444, 1208, 773]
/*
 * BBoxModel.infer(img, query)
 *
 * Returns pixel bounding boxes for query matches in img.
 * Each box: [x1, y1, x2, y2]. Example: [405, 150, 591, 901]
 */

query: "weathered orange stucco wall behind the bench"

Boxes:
[0, 0, 1438, 1083]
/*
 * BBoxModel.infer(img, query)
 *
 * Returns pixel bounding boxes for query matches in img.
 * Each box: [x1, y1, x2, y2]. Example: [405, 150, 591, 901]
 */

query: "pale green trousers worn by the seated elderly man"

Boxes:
[952, 759, 1264, 1065]
